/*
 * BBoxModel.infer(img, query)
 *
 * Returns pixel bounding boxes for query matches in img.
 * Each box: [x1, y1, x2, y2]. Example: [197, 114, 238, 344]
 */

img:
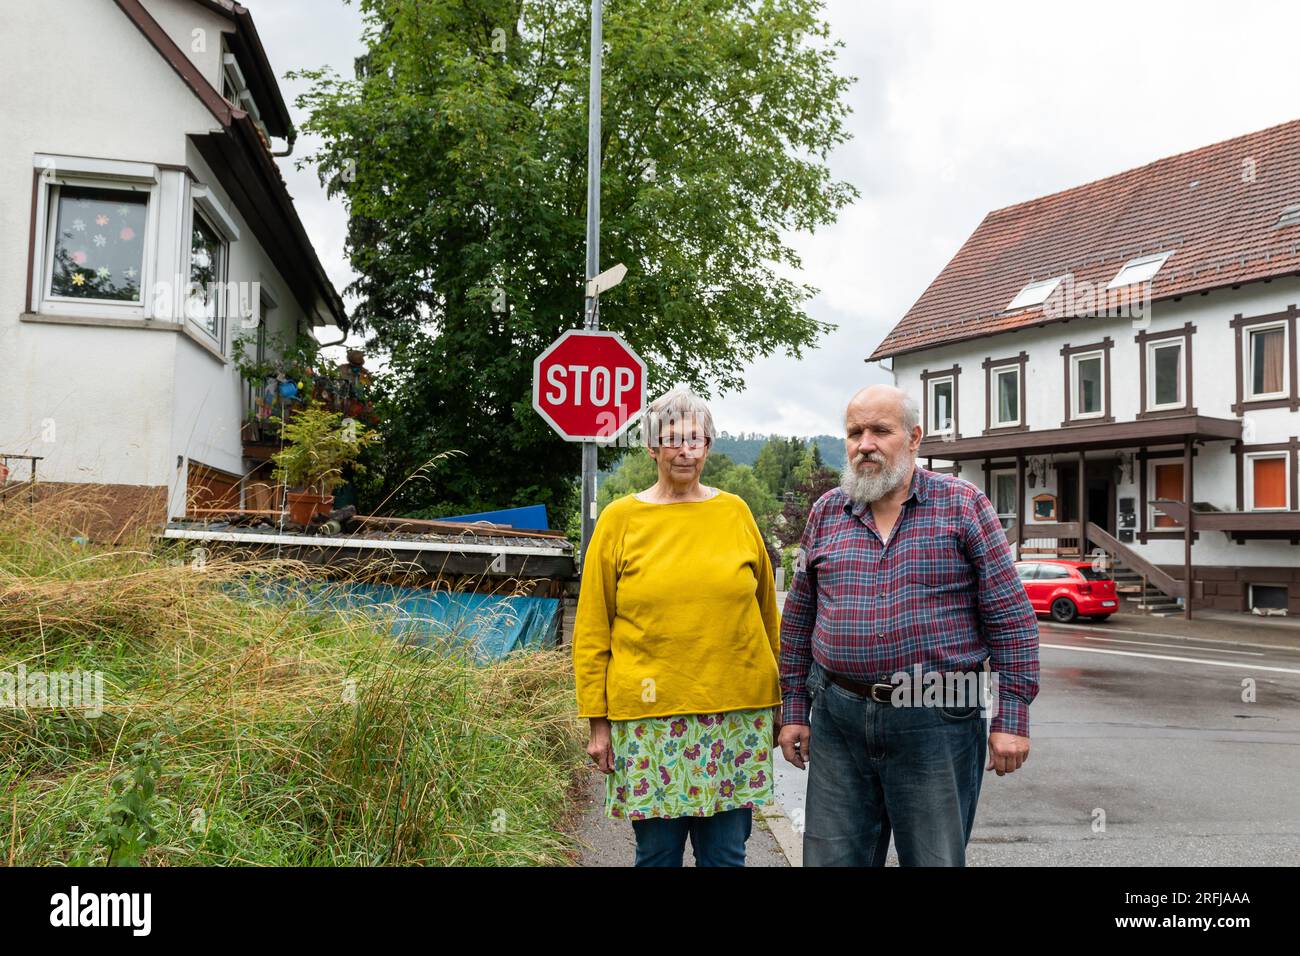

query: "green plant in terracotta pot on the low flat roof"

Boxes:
[270, 402, 377, 527]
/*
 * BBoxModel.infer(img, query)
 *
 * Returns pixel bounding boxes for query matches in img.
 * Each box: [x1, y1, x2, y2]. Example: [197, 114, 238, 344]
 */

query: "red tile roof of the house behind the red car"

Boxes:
[868, 120, 1300, 362]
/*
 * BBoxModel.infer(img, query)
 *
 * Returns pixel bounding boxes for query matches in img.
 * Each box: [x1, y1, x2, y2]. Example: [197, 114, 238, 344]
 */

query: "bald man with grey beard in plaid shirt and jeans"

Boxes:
[780, 385, 1039, 866]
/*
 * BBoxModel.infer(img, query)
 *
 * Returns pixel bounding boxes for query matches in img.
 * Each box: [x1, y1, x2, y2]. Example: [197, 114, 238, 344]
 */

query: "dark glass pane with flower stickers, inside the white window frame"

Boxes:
[49, 180, 148, 302]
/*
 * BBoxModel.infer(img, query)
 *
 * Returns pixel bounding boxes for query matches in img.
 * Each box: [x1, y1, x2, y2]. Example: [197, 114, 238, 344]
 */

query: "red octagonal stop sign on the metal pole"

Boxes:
[533, 329, 646, 442]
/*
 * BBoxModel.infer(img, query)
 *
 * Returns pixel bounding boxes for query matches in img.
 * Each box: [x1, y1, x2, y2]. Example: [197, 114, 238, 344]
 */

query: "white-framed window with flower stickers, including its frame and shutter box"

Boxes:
[31, 155, 159, 316]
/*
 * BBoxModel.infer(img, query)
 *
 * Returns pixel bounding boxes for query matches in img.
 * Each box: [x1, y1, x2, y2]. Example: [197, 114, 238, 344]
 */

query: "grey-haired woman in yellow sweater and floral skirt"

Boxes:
[573, 389, 781, 866]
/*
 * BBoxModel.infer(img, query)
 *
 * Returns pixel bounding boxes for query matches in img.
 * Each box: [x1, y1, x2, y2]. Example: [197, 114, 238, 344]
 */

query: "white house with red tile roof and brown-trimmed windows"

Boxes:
[868, 121, 1300, 614]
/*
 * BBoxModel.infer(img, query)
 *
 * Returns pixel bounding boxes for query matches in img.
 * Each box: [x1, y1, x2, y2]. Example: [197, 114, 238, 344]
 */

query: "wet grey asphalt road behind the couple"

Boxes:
[776, 615, 1300, 866]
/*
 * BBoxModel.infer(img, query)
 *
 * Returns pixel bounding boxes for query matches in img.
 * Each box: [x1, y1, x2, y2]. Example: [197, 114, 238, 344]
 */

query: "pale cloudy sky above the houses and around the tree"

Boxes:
[253, 0, 1300, 434]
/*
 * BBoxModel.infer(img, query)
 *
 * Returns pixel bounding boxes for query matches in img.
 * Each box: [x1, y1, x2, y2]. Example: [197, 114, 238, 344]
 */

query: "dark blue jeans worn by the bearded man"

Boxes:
[803, 661, 988, 866]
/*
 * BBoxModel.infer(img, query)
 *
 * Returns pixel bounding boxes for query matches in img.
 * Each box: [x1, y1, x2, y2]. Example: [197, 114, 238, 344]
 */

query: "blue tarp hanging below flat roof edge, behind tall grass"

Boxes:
[245, 581, 560, 663]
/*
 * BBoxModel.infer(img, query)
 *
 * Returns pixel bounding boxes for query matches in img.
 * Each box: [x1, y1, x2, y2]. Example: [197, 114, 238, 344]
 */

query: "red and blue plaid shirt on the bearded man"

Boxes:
[781, 466, 1039, 736]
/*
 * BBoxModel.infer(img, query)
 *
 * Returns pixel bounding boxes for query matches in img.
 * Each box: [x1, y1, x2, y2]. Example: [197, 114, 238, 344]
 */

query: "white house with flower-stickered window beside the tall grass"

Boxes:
[0, 0, 347, 538]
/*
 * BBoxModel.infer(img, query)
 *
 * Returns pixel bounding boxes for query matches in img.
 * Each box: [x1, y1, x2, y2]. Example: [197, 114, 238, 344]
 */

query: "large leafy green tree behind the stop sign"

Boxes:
[293, 0, 857, 522]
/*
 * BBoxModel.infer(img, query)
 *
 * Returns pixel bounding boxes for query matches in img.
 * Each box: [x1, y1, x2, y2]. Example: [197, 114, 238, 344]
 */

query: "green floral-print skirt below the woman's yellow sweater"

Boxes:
[605, 708, 772, 819]
